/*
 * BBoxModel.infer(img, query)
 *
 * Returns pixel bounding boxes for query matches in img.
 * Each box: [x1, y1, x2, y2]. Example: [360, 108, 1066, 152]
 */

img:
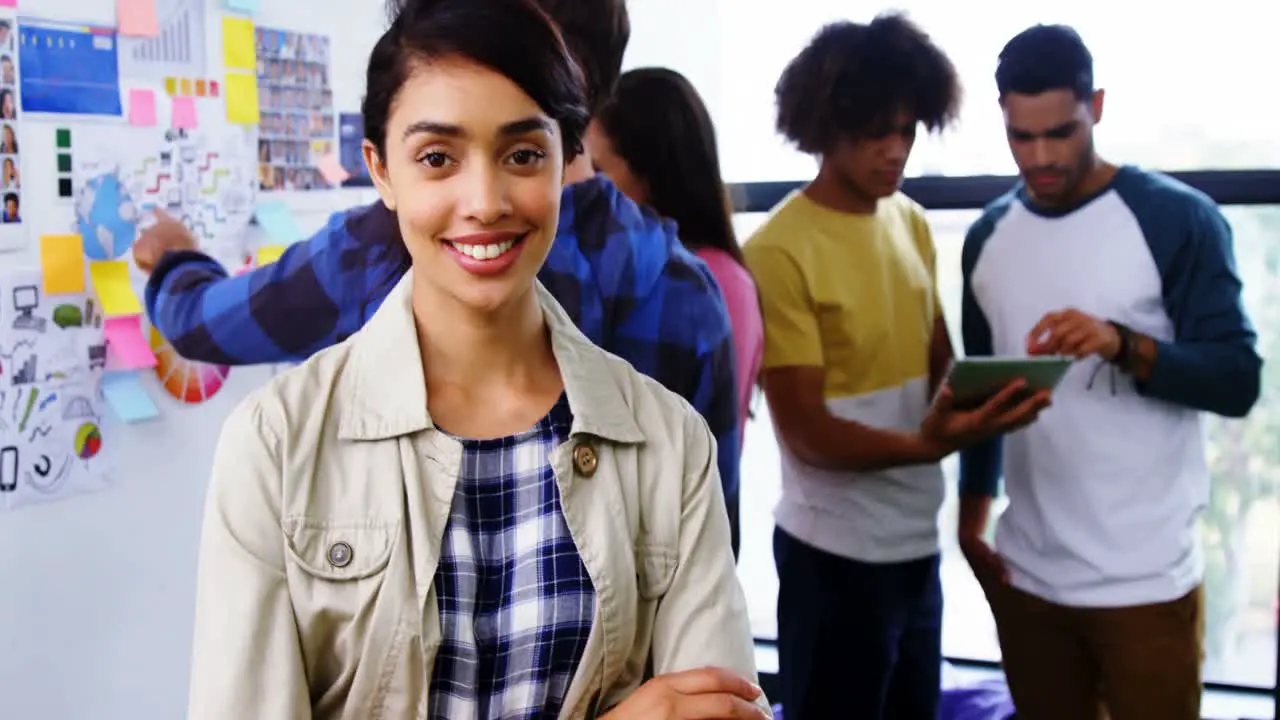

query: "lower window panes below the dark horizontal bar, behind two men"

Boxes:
[736, 205, 1280, 688]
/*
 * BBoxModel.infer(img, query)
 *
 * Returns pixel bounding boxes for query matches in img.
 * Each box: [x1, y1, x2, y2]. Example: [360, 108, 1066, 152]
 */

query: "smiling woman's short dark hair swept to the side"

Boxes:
[361, 0, 590, 161]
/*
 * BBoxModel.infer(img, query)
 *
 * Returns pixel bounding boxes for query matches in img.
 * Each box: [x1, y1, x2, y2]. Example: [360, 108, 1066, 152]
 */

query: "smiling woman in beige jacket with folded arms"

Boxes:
[188, 0, 768, 720]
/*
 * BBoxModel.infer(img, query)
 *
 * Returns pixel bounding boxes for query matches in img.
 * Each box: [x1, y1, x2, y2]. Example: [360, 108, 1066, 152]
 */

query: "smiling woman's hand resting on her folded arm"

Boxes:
[600, 667, 768, 720]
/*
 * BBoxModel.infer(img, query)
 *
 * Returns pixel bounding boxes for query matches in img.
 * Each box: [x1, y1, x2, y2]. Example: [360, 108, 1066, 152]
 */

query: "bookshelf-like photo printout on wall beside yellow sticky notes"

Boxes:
[255, 27, 335, 191]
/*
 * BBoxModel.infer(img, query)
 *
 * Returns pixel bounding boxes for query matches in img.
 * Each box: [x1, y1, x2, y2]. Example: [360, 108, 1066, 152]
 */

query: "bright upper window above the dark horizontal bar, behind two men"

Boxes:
[711, 0, 1280, 182]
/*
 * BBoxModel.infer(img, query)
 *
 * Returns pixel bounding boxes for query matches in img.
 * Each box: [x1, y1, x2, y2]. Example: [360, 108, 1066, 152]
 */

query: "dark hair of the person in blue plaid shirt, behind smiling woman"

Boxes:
[387, 0, 631, 117]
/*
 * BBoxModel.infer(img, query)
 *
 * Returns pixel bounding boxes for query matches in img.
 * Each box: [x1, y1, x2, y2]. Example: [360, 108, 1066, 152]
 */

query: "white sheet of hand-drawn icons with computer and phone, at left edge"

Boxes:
[0, 270, 108, 509]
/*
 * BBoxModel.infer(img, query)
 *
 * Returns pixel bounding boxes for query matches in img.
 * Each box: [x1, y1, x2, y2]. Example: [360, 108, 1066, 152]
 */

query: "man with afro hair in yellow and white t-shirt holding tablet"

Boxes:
[745, 14, 1048, 720]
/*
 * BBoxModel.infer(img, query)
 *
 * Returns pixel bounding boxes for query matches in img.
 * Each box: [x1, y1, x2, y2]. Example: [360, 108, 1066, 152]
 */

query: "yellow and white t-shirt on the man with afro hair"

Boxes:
[744, 192, 943, 562]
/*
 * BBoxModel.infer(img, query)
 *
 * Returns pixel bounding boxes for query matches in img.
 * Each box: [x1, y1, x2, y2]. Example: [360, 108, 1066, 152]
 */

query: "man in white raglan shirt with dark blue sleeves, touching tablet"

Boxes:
[960, 26, 1261, 720]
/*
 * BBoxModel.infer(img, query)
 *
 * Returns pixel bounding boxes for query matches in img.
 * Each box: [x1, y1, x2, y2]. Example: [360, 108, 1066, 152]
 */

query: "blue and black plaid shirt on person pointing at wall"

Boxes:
[146, 176, 741, 497]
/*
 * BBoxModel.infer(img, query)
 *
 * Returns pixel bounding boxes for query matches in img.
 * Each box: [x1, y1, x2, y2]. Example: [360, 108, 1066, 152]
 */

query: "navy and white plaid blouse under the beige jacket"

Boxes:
[428, 395, 595, 720]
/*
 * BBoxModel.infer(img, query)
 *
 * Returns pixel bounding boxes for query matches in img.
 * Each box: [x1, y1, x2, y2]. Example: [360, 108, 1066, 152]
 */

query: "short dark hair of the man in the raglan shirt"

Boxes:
[996, 24, 1093, 101]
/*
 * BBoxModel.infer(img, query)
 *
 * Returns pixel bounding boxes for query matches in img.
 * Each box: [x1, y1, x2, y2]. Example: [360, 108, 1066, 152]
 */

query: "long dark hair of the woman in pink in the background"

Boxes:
[596, 68, 742, 264]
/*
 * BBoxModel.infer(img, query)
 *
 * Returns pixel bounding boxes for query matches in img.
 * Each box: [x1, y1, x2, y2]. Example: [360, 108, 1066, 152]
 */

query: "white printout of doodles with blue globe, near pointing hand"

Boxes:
[74, 113, 257, 268]
